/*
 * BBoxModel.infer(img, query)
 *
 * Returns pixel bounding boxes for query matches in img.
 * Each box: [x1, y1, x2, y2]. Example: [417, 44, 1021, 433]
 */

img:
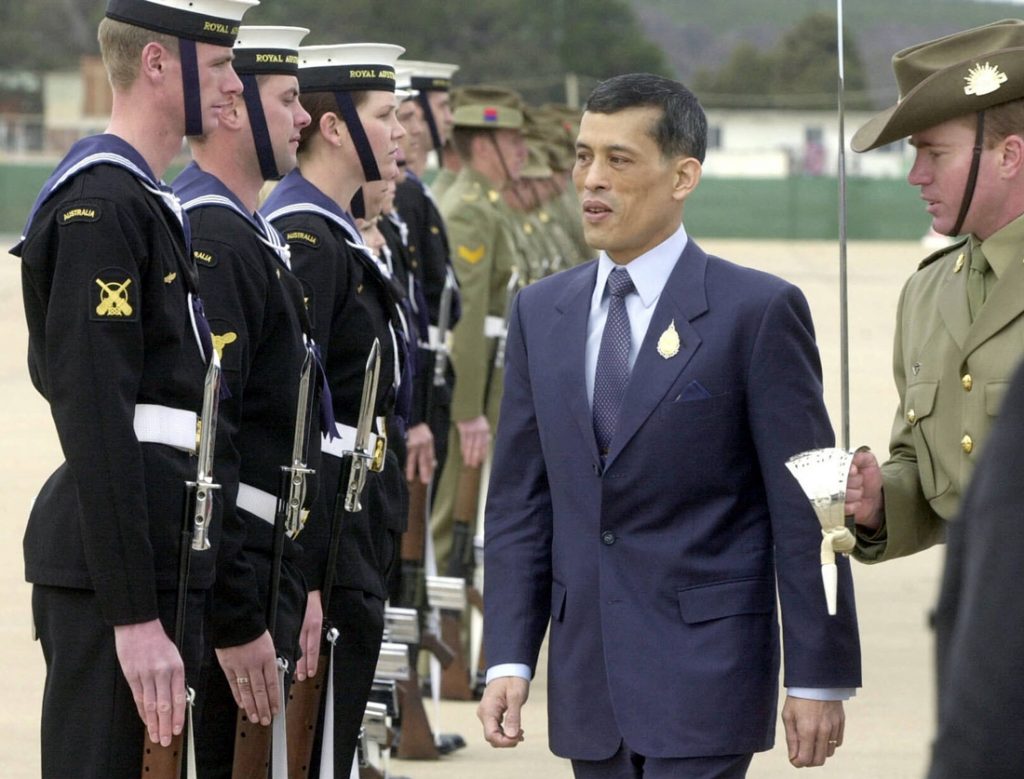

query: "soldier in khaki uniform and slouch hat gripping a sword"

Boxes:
[847, 19, 1024, 562]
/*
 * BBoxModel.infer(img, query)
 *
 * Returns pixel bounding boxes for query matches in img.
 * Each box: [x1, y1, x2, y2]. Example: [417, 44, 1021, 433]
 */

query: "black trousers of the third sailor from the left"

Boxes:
[309, 588, 384, 777]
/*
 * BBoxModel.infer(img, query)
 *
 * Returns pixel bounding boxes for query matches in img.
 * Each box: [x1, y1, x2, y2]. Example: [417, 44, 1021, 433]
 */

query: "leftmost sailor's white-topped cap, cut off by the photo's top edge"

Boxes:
[106, 0, 259, 46]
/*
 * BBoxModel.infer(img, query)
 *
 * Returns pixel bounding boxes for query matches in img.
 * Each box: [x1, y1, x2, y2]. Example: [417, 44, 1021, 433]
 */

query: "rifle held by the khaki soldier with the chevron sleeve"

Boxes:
[441, 269, 519, 700]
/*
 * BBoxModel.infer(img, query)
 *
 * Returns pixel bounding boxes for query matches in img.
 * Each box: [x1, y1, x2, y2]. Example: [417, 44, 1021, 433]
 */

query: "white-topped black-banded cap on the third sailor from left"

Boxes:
[299, 43, 406, 92]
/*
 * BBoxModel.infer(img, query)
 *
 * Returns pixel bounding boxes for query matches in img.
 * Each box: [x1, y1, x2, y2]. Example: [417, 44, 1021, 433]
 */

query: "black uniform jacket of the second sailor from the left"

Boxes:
[174, 164, 319, 647]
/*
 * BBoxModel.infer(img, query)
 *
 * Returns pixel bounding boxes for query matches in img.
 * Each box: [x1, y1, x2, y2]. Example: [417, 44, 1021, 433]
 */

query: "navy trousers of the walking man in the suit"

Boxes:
[572, 741, 754, 779]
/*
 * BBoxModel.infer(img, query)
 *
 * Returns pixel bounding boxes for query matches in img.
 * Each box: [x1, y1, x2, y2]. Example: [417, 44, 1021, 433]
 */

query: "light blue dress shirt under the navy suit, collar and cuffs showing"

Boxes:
[486, 224, 856, 700]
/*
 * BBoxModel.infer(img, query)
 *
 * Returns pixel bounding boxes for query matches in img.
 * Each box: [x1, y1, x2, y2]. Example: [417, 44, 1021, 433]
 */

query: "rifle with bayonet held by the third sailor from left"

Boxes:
[288, 338, 383, 779]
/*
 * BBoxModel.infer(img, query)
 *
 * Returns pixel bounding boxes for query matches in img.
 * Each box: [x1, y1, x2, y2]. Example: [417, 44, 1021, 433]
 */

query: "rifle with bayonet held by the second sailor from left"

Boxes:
[231, 346, 316, 779]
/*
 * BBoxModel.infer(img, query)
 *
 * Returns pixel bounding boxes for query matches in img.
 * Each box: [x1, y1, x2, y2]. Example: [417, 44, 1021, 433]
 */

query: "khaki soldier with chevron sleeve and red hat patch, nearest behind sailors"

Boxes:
[431, 87, 526, 573]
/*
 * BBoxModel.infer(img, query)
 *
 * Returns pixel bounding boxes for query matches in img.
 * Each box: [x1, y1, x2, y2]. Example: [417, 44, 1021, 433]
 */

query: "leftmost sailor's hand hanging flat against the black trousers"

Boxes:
[114, 619, 186, 746]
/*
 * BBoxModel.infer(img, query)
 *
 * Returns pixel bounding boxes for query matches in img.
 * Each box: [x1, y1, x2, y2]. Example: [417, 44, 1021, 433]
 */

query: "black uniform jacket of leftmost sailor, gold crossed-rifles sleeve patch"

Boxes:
[14, 135, 208, 624]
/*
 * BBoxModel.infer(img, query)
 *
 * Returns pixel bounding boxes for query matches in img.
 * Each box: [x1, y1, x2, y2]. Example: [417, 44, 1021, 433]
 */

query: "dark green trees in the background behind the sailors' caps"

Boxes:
[0, 0, 671, 102]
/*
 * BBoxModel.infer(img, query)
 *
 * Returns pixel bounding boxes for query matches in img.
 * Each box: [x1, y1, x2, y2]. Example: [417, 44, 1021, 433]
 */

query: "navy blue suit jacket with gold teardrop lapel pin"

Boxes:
[484, 240, 860, 760]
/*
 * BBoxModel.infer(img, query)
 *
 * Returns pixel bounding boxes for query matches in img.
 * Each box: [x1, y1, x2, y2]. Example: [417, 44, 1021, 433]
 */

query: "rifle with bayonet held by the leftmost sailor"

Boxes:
[141, 350, 220, 779]
